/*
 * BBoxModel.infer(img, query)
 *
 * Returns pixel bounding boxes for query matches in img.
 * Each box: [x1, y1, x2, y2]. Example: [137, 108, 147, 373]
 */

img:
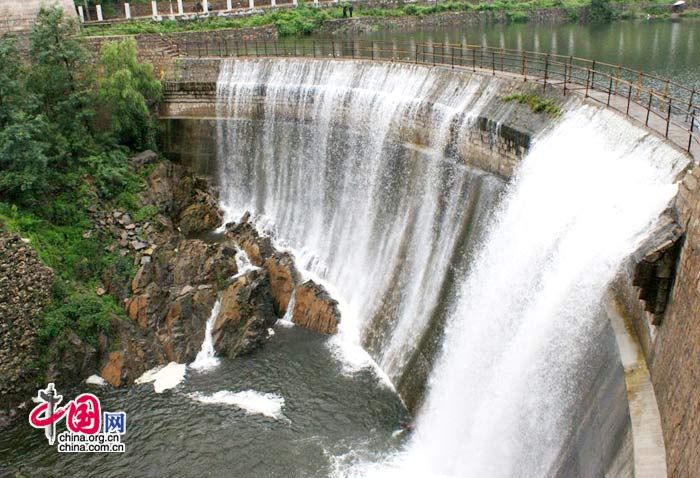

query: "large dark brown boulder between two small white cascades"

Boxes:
[212, 270, 277, 358]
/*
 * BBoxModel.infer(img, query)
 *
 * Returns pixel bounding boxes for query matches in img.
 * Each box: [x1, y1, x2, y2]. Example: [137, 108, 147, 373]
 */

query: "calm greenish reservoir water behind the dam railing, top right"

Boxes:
[336, 18, 700, 89]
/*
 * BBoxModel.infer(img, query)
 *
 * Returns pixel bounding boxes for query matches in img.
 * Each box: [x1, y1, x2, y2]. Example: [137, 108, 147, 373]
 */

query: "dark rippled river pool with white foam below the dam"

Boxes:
[0, 323, 410, 478]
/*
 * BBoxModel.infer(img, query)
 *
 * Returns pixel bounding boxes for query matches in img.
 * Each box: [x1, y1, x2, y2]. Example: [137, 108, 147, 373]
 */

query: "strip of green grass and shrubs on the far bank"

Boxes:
[83, 0, 692, 36]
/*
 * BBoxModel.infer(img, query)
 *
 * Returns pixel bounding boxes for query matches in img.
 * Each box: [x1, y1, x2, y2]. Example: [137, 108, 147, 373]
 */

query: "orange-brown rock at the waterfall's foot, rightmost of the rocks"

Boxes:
[292, 280, 340, 335]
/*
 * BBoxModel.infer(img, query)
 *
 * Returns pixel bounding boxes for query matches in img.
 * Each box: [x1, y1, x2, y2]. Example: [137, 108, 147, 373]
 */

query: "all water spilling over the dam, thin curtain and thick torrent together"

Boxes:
[217, 61, 683, 477]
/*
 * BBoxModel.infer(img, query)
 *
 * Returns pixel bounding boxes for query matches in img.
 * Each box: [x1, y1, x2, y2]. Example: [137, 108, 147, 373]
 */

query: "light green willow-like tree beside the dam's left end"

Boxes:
[99, 38, 162, 149]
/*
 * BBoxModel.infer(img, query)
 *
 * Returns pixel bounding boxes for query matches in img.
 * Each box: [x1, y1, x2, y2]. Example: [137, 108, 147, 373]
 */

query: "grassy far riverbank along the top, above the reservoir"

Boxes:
[83, 0, 700, 37]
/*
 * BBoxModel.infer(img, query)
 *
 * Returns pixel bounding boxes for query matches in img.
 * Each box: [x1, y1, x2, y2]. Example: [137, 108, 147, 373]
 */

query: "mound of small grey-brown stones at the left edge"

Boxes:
[0, 233, 53, 405]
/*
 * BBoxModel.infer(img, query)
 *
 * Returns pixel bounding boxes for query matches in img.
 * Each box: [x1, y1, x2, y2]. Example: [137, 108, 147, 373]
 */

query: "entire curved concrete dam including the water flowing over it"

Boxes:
[161, 54, 694, 477]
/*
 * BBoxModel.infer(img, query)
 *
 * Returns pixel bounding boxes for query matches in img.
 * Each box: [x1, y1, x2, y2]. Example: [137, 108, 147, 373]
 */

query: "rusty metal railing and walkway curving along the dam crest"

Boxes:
[179, 38, 700, 155]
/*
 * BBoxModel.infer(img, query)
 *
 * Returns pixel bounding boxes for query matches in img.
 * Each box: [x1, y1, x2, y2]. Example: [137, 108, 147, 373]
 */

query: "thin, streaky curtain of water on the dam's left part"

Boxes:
[217, 60, 503, 388]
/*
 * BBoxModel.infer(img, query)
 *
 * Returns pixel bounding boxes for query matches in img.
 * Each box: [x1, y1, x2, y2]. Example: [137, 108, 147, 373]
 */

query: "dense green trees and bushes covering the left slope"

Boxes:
[0, 8, 161, 352]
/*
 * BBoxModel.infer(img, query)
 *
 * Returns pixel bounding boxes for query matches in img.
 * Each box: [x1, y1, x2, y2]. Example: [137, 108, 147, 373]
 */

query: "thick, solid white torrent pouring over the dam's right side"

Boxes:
[341, 107, 684, 478]
